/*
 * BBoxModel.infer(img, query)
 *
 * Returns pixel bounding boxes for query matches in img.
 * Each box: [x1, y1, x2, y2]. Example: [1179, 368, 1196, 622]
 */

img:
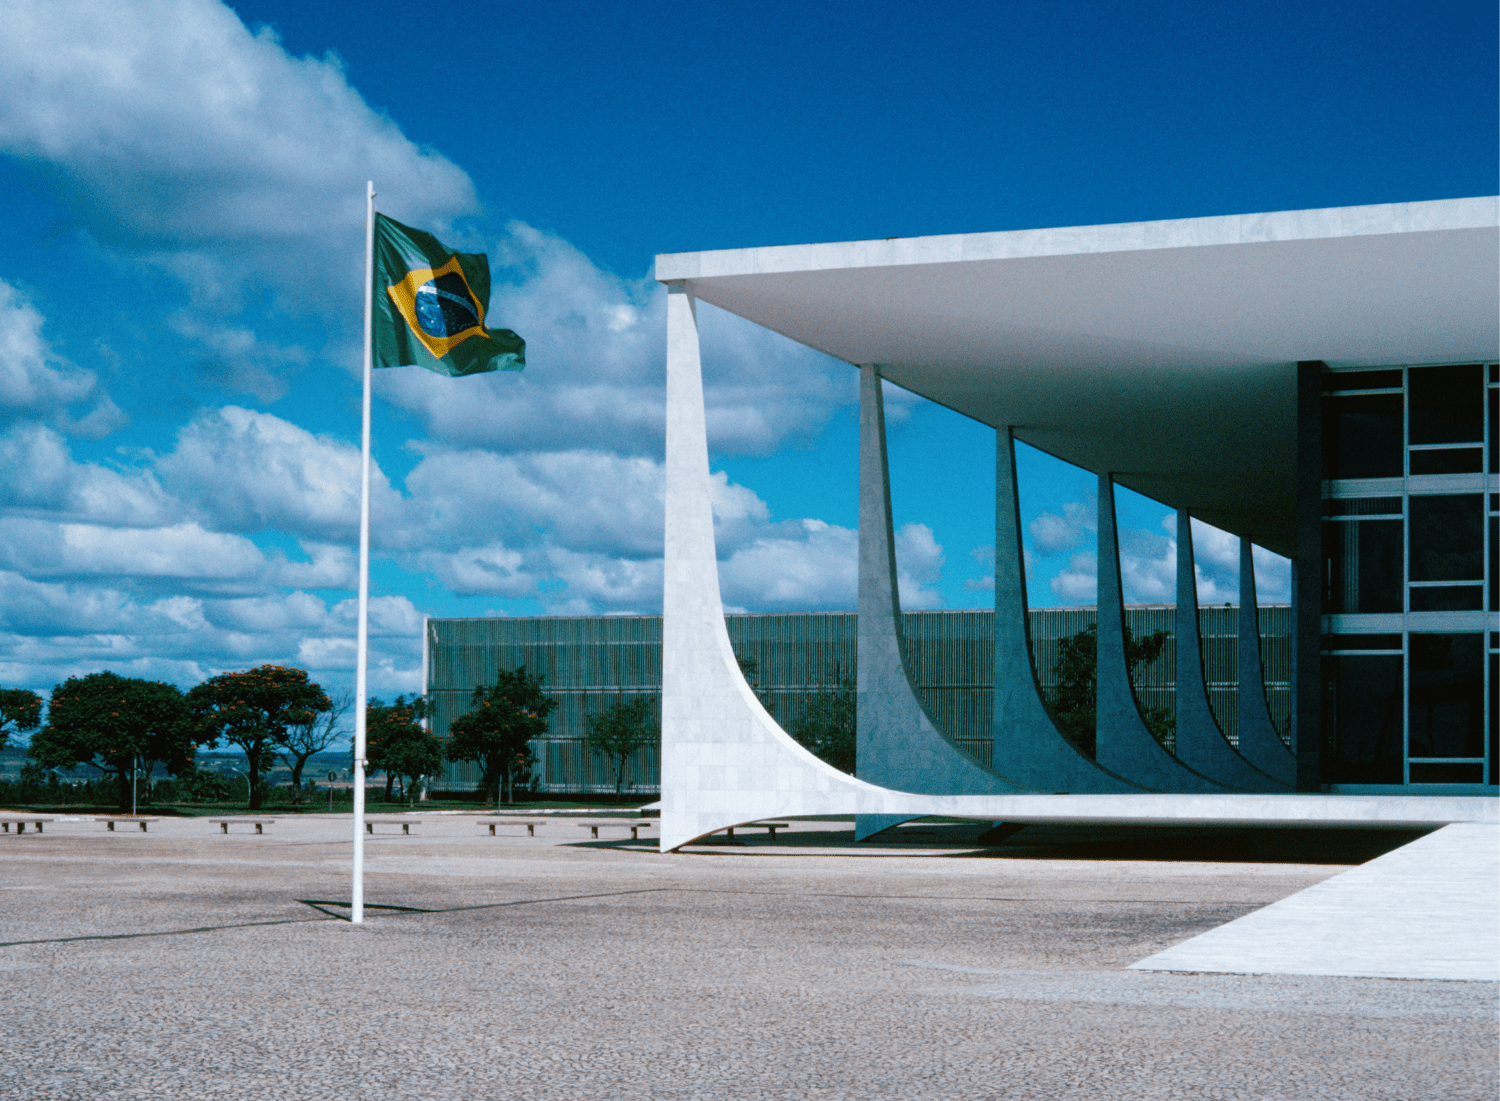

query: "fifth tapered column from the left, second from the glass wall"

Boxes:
[1176, 509, 1290, 792]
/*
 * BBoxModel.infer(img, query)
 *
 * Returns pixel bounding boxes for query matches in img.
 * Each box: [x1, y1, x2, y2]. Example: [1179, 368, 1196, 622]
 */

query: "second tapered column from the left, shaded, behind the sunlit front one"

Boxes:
[855, 363, 1026, 840]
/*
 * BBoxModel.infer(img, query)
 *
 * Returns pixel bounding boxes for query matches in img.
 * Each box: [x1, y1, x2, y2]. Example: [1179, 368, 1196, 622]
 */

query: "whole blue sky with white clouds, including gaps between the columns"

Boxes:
[0, 0, 1497, 708]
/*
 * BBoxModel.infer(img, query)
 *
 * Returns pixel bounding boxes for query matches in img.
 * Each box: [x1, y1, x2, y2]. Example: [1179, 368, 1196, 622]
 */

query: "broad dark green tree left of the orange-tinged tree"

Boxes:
[27, 672, 204, 812]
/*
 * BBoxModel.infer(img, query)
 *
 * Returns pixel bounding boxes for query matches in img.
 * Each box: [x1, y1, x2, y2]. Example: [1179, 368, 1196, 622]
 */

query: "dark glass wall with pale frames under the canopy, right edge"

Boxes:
[1322, 363, 1500, 792]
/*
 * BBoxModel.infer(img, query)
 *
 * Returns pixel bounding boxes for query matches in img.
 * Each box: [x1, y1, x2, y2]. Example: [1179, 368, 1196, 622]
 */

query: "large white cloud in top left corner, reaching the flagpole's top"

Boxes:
[0, 0, 477, 297]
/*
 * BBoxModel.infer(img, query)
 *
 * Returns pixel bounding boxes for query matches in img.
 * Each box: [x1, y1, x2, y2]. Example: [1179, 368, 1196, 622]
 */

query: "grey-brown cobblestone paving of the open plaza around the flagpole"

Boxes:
[0, 816, 1497, 1101]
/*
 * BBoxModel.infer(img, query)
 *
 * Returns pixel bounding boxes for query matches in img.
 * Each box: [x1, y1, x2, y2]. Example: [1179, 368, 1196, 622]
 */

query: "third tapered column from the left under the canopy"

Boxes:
[993, 428, 1149, 792]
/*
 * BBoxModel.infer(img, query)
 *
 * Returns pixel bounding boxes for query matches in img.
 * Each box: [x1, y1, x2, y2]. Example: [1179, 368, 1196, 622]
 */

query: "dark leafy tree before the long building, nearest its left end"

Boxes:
[447, 666, 558, 806]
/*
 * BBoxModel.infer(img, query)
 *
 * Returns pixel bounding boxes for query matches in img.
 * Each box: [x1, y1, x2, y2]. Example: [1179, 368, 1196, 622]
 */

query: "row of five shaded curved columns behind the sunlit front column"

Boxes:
[857, 365, 1295, 804]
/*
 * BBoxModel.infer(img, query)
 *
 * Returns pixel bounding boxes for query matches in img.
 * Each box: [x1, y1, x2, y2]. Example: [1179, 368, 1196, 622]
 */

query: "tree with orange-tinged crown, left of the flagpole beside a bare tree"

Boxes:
[188, 665, 333, 810]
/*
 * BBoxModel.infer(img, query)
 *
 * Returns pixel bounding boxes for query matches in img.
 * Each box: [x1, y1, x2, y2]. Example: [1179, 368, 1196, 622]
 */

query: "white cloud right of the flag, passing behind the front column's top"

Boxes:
[377, 222, 858, 458]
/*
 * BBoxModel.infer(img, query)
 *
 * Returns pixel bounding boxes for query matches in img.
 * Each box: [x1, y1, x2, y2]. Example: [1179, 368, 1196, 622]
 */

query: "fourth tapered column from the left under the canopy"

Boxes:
[1095, 474, 1226, 792]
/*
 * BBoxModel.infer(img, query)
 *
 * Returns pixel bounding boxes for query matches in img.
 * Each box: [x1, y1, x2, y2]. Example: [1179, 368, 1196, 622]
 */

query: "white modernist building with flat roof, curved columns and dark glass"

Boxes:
[657, 198, 1500, 848]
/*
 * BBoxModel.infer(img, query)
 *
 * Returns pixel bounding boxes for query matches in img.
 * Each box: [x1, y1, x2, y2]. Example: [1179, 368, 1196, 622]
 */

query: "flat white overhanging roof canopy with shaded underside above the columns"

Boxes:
[656, 198, 1500, 555]
